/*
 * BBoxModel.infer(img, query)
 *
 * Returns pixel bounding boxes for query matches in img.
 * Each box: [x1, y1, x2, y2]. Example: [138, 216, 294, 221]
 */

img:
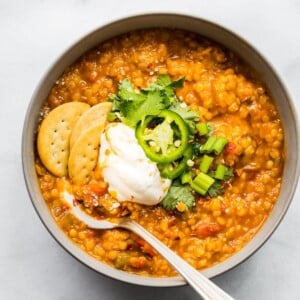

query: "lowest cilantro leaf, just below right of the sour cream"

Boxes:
[161, 181, 195, 210]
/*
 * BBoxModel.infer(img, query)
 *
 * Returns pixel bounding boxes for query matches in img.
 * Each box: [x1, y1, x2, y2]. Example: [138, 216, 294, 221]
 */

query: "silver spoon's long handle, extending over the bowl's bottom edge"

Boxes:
[119, 220, 234, 300]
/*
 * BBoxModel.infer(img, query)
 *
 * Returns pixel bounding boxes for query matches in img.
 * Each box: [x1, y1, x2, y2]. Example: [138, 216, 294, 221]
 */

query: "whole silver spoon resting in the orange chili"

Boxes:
[64, 193, 234, 300]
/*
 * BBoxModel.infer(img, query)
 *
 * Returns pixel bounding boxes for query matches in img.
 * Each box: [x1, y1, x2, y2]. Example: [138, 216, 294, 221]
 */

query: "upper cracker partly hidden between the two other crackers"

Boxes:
[70, 102, 112, 148]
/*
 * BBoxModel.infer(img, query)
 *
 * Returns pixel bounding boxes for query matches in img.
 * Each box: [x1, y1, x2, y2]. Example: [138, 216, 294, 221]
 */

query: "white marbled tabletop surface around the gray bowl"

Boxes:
[0, 0, 300, 300]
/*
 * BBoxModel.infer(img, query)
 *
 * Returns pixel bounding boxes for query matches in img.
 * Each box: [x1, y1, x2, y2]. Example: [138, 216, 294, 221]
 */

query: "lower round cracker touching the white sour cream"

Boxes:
[68, 121, 106, 184]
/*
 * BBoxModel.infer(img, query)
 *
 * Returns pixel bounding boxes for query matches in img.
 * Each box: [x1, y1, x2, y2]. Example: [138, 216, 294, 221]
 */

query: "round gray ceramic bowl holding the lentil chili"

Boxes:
[22, 14, 300, 286]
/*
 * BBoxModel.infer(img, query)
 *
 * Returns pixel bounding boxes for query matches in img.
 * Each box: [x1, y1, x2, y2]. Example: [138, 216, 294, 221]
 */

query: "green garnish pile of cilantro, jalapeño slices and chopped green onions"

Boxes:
[109, 75, 233, 212]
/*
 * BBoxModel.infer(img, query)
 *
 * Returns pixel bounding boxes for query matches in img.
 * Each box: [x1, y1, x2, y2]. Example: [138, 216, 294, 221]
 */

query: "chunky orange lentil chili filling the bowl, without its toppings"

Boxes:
[36, 29, 284, 276]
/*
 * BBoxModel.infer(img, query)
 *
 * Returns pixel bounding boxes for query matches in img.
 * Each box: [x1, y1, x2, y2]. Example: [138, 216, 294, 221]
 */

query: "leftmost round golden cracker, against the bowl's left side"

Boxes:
[37, 102, 90, 177]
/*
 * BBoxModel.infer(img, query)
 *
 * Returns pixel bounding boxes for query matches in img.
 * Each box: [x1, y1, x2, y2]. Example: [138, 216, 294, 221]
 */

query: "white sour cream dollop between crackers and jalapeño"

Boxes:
[99, 123, 171, 205]
